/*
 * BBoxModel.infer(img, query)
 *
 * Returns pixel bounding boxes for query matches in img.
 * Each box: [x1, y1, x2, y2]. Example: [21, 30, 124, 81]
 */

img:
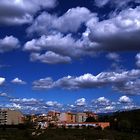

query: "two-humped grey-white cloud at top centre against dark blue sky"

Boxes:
[27, 7, 95, 34]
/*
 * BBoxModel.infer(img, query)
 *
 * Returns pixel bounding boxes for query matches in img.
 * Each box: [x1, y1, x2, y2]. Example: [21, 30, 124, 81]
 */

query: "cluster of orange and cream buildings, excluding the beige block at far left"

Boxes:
[32, 111, 110, 129]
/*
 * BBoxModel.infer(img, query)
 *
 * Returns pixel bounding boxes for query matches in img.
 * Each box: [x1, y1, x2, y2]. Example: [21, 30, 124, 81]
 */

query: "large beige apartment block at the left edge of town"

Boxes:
[0, 109, 23, 125]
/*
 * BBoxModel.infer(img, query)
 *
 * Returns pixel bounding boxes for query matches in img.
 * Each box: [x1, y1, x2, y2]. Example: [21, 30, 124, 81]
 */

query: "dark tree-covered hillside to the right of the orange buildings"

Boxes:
[99, 110, 140, 133]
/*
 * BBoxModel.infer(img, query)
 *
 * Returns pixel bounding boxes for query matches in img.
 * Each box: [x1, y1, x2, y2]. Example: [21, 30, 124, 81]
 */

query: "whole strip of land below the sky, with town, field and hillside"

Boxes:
[0, 109, 140, 140]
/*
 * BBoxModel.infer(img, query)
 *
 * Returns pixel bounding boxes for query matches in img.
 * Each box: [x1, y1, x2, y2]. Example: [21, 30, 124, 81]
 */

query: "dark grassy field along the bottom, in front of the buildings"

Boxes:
[0, 129, 140, 140]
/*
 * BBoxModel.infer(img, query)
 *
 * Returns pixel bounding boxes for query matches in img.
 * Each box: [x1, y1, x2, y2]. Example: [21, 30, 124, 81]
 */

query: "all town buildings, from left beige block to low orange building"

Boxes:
[0, 109, 110, 129]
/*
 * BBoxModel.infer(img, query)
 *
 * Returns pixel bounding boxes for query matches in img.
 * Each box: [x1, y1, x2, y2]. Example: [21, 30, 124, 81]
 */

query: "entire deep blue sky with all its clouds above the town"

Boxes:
[0, 0, 140, 113]
